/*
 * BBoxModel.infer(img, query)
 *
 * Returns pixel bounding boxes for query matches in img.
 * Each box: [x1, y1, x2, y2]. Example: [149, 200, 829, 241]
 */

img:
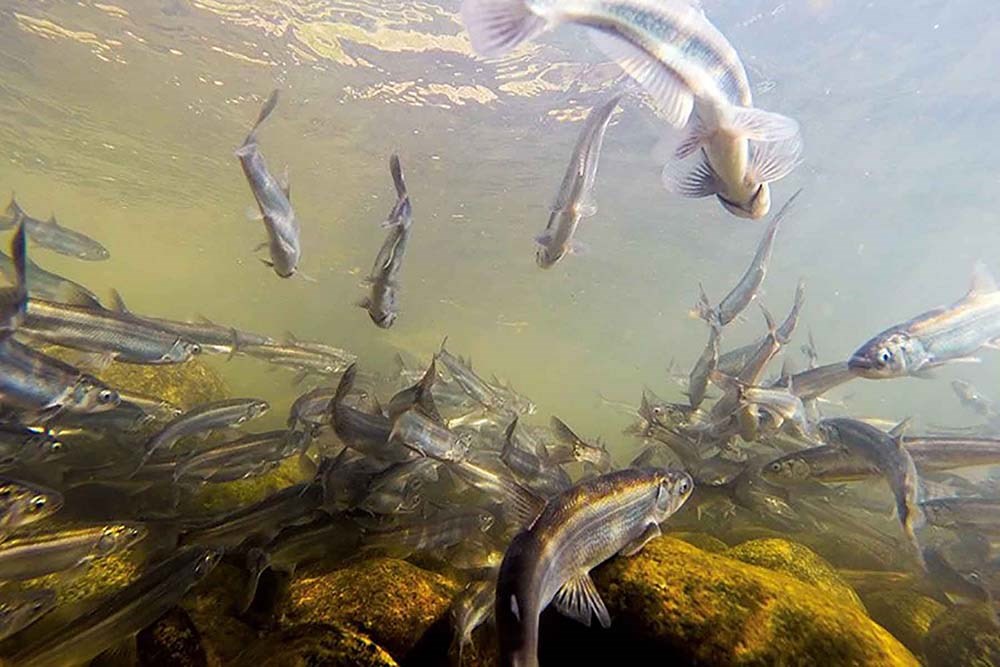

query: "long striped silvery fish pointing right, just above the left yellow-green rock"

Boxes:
[20, 299, 201, 364]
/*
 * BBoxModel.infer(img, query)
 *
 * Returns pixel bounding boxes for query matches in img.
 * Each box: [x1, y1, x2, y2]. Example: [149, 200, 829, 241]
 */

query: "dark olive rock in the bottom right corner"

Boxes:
[924, 604, 1000, 667]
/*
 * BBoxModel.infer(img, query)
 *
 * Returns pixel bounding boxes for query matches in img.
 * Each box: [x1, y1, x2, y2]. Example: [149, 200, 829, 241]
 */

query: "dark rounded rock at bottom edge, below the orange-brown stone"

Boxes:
[233, 623, 397, 667]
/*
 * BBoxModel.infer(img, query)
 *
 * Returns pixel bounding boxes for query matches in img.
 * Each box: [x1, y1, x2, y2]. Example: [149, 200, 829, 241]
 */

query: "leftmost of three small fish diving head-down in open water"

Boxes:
[236, 90, 302, 278]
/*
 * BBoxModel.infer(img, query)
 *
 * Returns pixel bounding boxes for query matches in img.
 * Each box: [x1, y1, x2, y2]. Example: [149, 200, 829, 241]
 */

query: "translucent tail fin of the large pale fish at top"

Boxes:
[461, 0, 546, 57]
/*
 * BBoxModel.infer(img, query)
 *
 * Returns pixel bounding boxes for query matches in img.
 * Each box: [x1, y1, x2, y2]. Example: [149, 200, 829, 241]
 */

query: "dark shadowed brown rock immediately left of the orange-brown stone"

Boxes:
[181, 562, 257, 665]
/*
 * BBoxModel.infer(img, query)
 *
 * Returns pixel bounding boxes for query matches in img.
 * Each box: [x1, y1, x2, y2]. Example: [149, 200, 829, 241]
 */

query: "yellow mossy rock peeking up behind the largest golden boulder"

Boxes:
[723, 538, 865, 611]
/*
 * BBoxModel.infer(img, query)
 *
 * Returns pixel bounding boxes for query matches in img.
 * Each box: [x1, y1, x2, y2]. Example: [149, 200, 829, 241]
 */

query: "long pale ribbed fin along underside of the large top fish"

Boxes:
[588, 30, 694, 127]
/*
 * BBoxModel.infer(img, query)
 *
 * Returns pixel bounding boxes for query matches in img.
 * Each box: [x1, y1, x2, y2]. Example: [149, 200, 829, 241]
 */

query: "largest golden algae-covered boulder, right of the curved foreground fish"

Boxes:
[588, 537, 918, 666]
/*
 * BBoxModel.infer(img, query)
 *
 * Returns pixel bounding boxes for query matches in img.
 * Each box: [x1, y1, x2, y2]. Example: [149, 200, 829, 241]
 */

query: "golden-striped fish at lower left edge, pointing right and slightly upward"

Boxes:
[0, 523, 147, 581]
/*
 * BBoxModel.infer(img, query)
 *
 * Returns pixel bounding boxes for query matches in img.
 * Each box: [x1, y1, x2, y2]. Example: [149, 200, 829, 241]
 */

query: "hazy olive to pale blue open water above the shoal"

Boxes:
[0, 0, 1000, 448]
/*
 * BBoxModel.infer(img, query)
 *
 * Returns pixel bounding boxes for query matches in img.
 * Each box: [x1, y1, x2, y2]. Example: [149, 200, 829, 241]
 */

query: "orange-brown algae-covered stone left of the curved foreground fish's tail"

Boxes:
[286, 558, 459, 660]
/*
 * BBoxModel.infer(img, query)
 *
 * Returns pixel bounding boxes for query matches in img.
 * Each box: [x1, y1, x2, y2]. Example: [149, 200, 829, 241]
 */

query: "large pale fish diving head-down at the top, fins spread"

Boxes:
[462, 0, 802, 219]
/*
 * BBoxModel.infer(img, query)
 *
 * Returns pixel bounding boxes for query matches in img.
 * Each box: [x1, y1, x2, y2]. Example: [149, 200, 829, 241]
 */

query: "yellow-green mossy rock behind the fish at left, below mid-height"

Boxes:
[97, 359, 229, 410]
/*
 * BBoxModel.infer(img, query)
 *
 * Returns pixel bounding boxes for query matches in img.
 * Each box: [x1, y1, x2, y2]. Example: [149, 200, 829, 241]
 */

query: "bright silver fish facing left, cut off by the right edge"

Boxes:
[847, 262, 1000, 380]
